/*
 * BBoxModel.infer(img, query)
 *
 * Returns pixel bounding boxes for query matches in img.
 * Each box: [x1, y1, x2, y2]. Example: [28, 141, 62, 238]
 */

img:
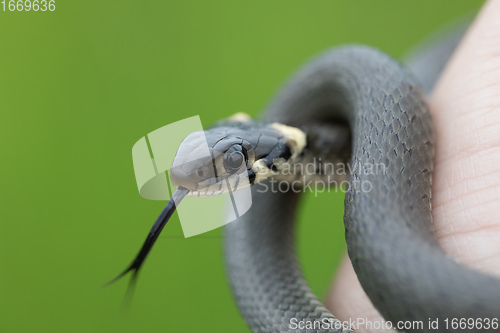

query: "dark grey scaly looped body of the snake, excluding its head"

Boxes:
[225, 37, 500, 332]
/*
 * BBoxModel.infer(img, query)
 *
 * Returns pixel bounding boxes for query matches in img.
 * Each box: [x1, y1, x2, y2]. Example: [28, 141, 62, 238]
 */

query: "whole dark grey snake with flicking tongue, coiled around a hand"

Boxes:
[113, 23, 500, 333]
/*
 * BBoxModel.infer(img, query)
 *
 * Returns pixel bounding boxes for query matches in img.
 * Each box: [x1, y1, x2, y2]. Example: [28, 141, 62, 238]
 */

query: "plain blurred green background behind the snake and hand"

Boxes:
[0, 0, 482, 332]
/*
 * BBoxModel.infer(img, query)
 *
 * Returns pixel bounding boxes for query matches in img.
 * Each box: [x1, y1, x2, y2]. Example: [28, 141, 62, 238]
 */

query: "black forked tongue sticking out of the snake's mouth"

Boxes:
[104, 187, 189, 292]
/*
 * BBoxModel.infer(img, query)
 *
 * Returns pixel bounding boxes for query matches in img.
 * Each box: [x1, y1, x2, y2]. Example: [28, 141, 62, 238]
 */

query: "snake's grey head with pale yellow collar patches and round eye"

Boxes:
[170, 120, 306, 197]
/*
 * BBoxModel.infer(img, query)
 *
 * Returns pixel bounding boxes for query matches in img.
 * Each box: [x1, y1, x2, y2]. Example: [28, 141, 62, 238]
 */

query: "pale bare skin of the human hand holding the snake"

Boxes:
[326, 0, 500, 333]
